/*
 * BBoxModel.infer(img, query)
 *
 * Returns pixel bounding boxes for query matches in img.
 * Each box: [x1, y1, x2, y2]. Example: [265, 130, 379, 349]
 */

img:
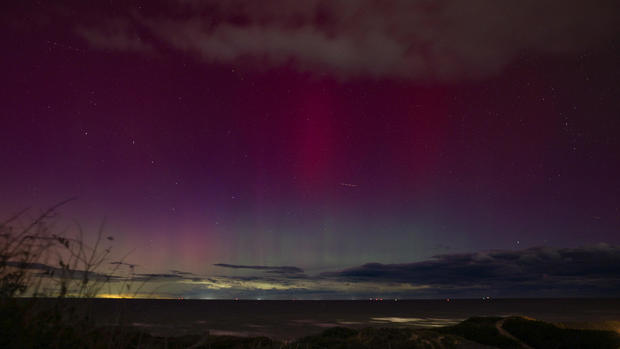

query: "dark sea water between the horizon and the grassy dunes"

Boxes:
[53, 299, 620, 339]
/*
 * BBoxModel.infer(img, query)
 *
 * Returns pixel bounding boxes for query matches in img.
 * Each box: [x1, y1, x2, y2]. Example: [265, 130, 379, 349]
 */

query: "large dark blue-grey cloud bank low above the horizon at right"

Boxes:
[321, 244, 620, 296]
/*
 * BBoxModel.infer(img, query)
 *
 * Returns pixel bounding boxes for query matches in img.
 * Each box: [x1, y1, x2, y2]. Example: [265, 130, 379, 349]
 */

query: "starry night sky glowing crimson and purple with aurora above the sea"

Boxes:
[0, 0, 620, 298]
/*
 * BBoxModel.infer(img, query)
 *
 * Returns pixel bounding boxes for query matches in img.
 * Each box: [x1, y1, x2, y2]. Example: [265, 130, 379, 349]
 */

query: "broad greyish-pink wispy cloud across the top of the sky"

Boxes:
[65, 0, 620, 80]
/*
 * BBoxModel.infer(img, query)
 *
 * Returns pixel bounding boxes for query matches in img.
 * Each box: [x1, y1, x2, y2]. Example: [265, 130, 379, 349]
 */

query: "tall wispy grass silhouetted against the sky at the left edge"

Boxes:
[0, 199, 144, 348]
